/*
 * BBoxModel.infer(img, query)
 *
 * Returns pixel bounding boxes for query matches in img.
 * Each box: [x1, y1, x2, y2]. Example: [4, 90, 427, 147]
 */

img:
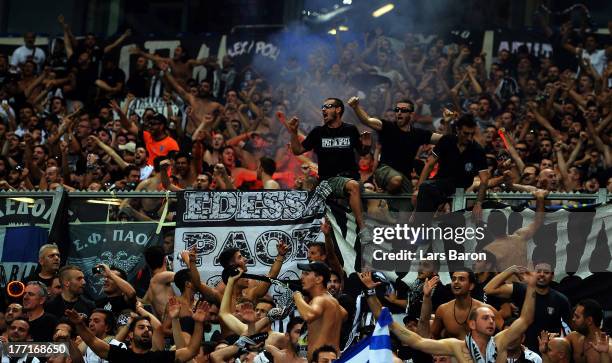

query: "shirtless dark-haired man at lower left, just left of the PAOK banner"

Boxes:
[144, 246, 174, 317]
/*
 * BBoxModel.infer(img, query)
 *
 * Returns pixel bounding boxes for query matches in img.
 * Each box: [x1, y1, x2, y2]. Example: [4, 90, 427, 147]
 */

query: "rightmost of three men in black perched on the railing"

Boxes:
[412, 114, 489, 220]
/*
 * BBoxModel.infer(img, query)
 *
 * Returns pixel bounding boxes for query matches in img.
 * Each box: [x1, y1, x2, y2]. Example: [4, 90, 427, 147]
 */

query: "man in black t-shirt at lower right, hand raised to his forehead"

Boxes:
[484, 262, 572, 352]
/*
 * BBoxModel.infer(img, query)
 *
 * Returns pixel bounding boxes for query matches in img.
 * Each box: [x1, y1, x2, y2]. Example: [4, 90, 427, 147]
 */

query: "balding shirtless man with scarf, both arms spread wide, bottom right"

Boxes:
[359, 272, 536, 363]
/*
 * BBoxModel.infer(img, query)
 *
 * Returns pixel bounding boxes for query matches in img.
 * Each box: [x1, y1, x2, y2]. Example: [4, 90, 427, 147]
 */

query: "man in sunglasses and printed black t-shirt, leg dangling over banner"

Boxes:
[285, 98, 371, 242]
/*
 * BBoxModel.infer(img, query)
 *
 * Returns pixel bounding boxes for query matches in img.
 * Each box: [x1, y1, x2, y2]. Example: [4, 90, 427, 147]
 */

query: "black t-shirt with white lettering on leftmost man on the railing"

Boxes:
[302, 123, 362, 180]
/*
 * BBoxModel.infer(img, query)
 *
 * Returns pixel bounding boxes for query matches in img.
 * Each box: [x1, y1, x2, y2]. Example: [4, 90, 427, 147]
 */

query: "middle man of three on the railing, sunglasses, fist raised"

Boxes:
[348, 97, 442, 210]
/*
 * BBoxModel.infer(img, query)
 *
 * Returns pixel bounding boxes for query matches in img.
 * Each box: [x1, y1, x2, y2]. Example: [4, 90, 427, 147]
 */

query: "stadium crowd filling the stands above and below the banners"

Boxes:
[0, 9, 612, 363]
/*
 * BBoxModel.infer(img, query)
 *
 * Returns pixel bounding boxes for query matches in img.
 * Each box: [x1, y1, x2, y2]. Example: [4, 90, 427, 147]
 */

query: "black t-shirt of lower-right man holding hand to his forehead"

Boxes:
[512, 282, 571, 352]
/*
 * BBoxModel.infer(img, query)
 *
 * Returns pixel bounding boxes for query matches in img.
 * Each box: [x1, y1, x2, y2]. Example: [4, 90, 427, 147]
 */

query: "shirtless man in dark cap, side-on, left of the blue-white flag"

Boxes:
[293, 262, 348, 361]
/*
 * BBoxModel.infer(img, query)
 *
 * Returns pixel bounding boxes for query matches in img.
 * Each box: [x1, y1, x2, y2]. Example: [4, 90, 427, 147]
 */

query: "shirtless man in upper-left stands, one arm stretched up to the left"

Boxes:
[160, 63, 223, 135]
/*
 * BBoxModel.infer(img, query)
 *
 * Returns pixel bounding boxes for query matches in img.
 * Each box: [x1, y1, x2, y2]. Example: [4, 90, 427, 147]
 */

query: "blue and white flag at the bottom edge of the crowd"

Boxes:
[334, 308, 393, 363]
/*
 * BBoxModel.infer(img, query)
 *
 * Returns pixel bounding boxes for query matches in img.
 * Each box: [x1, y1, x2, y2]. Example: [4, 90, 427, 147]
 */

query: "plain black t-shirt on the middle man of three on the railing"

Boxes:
[378, 120, 432, 177]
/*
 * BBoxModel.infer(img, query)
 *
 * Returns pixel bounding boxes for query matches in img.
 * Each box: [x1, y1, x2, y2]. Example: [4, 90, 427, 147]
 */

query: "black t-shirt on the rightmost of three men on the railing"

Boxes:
[433, 135, 487, 188]
